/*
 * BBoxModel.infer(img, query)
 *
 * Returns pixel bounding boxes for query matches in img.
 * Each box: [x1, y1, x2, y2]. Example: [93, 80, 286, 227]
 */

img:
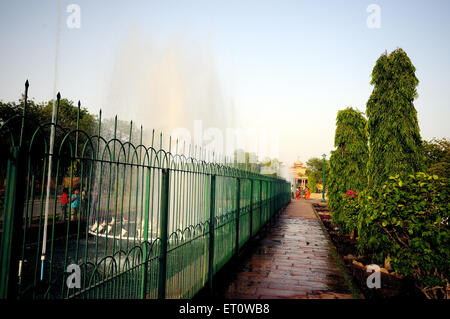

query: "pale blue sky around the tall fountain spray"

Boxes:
[0, 0, 450, 179]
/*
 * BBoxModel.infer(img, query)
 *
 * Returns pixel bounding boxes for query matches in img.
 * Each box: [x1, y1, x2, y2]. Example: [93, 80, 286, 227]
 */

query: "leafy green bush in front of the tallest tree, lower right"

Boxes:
[358, 173, 450, 297]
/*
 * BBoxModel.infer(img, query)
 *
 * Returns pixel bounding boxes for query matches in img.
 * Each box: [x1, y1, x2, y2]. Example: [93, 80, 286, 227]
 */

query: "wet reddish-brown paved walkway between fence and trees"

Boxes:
[221, 200, 352, 299]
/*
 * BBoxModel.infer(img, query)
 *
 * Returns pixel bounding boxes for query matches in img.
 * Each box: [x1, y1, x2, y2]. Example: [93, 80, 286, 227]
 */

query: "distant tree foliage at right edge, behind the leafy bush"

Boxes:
[423, 138, 450, 178]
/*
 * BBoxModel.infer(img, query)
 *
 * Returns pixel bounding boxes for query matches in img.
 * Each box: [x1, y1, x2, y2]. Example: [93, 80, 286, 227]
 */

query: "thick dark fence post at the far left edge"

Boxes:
[0, 146, 26, 299]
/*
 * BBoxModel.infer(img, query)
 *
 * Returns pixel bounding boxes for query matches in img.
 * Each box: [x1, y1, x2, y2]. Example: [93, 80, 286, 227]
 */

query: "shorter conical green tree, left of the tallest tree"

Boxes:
[328, 107, 368, 212]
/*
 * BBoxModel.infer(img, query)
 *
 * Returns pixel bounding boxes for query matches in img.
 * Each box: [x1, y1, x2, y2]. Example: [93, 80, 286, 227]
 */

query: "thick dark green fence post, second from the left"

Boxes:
[158, 168, 170, 299]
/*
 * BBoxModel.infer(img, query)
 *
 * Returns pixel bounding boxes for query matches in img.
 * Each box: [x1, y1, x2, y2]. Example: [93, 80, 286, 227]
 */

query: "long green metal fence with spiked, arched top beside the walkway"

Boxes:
[0, 82, 290, 298]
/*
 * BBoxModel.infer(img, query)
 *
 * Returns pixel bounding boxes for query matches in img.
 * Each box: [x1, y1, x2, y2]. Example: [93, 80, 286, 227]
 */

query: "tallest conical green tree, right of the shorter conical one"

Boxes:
[366, 48, 424, 188]
